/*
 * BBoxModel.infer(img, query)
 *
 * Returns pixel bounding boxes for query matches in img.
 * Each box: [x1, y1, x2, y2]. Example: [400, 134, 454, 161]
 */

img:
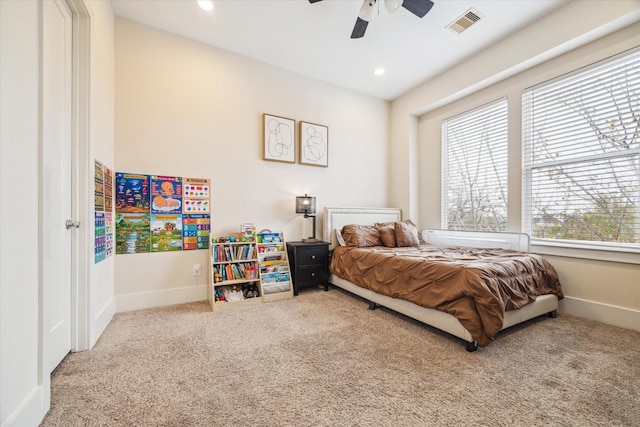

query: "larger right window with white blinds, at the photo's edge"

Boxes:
[522, 49, 640, 249]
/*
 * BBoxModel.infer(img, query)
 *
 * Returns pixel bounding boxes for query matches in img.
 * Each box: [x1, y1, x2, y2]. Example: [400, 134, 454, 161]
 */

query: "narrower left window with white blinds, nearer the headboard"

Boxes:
[442, 98, 508, 231]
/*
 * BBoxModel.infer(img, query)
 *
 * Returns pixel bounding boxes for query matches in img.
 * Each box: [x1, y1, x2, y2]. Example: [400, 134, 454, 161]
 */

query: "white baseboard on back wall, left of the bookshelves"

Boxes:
[116, 285, 207, 313]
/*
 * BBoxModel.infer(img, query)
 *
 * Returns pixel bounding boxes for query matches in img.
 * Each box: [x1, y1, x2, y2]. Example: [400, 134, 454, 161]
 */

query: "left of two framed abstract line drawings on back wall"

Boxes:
[262, 114, 296, 163]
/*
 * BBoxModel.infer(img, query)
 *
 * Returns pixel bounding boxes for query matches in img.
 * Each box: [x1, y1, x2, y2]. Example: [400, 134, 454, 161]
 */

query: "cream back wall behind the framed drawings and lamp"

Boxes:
[115, 18, 389, 311]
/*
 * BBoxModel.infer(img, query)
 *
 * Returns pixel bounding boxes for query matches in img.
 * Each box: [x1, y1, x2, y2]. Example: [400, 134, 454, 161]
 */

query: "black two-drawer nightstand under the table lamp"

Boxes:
[287, 242, 329, 295]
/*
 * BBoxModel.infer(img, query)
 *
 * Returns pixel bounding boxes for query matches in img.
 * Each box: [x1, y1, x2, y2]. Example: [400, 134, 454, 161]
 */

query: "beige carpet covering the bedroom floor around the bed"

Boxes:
[42, 288, 640, 427]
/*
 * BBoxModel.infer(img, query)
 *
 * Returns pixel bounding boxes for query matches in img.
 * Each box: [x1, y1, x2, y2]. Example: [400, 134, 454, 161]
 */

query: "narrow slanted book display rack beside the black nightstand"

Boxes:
[256, 232, 293, 302]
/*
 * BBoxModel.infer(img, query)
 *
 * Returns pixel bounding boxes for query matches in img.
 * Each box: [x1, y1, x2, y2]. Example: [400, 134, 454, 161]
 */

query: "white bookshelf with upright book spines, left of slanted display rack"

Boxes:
[208, 240, 262, 311]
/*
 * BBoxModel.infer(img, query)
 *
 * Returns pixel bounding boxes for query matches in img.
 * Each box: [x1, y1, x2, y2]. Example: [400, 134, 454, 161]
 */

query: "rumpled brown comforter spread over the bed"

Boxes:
[330, 245, 563, 346]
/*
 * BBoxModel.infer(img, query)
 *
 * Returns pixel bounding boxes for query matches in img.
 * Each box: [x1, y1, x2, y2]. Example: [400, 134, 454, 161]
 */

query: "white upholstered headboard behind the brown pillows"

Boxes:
[324, 208, 402, 250]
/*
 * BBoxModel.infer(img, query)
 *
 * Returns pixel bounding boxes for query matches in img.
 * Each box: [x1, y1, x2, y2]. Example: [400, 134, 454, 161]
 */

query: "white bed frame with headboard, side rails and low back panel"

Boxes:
[323, 207, 558, 352]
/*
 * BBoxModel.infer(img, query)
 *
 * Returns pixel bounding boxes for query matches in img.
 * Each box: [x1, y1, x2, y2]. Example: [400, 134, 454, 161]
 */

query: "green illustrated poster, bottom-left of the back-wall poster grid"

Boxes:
[116, 213, 151, 254]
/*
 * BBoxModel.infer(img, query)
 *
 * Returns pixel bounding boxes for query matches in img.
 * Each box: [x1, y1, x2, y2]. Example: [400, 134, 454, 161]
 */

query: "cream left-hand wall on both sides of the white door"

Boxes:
[0, 0, 115, 427]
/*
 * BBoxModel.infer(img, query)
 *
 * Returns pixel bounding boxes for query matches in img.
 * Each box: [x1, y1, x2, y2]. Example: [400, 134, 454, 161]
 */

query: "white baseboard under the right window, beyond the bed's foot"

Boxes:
[558, 297, 640, 331]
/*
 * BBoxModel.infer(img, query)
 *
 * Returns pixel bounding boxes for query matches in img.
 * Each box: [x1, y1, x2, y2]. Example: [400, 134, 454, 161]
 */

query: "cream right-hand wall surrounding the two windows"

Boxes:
[390, 1, 640, 329]
